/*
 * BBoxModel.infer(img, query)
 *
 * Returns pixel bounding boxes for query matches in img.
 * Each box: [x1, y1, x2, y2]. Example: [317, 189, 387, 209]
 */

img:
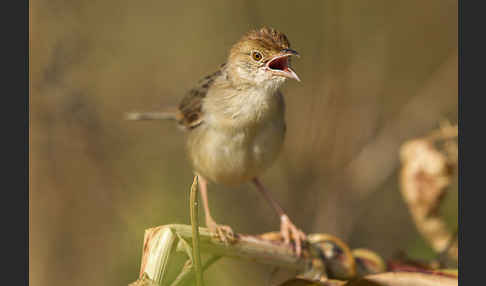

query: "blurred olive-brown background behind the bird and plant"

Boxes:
[29, 0, 458, 285]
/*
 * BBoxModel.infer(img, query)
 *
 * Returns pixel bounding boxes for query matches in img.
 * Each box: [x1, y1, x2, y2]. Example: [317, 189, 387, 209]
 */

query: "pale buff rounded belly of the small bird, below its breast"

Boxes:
[188, 118, 285, 186]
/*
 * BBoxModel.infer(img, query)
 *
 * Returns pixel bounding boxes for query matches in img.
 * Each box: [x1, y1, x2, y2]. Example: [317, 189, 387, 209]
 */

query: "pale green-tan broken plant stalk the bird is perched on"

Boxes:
[131, 224, 316, 286]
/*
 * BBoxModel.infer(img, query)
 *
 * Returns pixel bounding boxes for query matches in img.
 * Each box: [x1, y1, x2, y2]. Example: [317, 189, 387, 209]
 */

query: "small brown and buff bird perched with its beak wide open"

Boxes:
[129, 27, 306, 255]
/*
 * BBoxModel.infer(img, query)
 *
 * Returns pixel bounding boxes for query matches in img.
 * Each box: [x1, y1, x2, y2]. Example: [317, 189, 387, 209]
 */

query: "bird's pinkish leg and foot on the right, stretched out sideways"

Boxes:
[253, 178, 307, 256]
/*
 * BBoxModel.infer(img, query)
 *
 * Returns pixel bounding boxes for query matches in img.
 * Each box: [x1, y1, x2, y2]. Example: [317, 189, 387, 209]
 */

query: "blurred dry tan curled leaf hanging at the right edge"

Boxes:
[400, 125, 458, 261]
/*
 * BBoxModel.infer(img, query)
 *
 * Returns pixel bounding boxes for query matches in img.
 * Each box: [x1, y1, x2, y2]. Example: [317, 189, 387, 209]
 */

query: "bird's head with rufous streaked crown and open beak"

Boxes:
[227, 27, 300, 88]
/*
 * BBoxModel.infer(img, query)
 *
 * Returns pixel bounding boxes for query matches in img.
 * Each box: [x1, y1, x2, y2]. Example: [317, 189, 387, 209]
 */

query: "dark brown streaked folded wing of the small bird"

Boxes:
[177, 67, 224, 129]
